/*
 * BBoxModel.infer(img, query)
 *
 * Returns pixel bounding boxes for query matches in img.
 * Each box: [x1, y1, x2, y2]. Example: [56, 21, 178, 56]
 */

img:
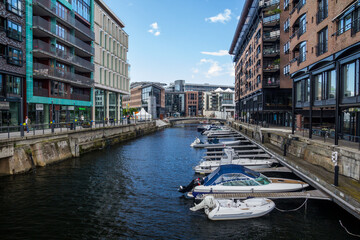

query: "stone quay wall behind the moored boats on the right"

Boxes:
[231, 122, 360, 181]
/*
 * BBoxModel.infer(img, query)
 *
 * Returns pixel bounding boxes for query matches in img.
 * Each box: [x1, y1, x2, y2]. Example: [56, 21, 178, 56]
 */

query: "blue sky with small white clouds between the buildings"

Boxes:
[104, 0, 245, 85]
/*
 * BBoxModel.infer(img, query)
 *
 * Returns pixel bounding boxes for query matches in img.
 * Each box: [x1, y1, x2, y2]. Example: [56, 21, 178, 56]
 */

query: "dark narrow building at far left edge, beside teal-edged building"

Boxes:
[0, 0, 26, 127]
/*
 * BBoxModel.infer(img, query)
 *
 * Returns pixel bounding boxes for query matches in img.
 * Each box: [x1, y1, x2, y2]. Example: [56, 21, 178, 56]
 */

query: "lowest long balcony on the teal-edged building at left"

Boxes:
[33, 63, 93, 87]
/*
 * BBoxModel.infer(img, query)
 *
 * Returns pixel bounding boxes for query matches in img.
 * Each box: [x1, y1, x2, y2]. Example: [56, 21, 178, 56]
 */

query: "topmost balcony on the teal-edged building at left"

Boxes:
[33, 0, 95, 40]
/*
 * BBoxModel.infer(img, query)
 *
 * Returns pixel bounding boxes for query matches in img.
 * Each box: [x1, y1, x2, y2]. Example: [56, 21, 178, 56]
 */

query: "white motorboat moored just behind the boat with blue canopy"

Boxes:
[194, 147, 274, 174]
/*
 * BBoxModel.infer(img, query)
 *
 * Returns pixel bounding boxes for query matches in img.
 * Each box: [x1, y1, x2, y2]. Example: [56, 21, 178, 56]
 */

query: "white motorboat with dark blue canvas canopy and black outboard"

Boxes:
[179, 164, 309, 197]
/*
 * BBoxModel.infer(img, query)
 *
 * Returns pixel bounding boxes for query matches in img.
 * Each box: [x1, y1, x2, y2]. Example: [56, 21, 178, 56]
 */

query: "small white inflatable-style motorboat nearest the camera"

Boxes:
[190, 196, 275, 220]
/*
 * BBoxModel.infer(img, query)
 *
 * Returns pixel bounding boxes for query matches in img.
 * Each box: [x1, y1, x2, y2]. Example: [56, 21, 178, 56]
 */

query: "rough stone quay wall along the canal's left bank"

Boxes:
[0, 122, 159, 176]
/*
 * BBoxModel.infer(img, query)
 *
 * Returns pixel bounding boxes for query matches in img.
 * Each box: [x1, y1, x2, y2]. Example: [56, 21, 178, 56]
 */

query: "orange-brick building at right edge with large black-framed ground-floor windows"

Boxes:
[290, 0, 360, 144]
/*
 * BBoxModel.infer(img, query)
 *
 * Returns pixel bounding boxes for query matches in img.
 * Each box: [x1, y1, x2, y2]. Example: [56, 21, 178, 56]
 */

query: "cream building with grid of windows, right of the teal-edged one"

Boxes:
[93, 0, 130, 121]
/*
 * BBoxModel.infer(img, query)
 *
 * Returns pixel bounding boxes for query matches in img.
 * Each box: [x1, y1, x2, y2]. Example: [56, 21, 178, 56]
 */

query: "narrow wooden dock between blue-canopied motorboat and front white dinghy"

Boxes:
[196, 190, 331, 200]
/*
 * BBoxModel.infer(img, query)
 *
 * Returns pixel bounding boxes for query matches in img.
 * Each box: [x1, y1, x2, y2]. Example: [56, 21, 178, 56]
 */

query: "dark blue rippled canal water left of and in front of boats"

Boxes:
[0, 126, 360, 240]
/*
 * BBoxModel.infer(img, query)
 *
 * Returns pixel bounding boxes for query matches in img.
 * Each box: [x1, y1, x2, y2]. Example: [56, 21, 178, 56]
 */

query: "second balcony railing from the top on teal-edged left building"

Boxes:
[33, 16, 94, 54]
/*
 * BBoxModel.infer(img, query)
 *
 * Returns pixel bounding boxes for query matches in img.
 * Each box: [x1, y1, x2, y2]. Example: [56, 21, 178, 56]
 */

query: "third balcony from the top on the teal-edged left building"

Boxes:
[33, 39, 94, 71]
